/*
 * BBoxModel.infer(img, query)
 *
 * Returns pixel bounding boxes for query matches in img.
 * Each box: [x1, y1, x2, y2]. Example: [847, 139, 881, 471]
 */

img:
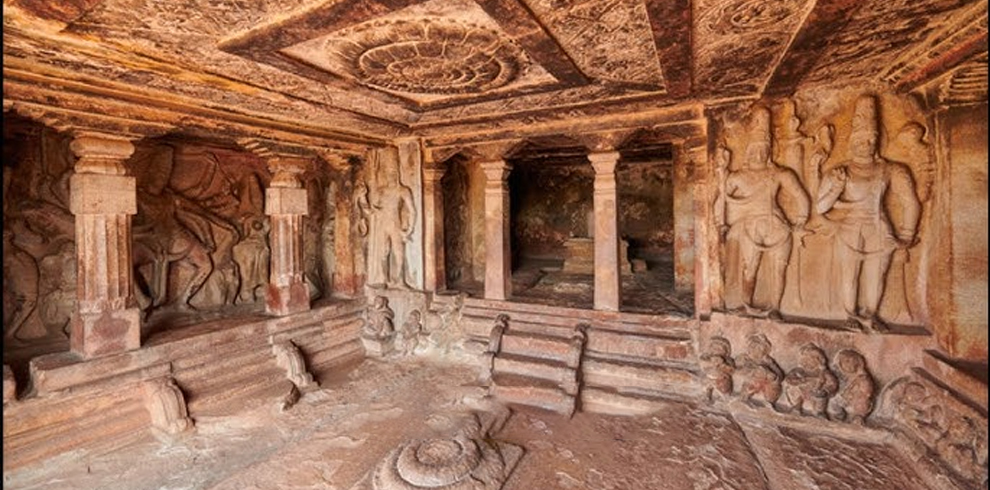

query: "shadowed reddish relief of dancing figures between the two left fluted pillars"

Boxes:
[130, 144, 268, 313]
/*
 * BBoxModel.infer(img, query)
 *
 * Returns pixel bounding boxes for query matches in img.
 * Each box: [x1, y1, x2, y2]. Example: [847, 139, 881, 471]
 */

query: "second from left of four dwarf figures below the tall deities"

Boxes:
[735, 333, 784, 406]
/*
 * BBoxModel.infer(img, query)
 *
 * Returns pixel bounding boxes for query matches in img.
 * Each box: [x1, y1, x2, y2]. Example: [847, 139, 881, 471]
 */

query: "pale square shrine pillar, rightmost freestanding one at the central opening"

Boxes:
[588, 151, 622, 311]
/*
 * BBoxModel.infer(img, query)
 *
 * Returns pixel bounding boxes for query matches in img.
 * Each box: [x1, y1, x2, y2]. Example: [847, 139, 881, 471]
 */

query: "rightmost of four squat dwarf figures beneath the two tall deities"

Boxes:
[828, 349, 877, 424]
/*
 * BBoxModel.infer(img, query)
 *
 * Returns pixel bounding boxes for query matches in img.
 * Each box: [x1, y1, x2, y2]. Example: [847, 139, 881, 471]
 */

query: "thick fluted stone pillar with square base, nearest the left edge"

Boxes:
[69, 133, 141, 358]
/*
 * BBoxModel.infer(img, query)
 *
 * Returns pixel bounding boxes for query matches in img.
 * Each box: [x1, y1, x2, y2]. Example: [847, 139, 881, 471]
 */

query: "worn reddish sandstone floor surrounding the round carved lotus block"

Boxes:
[3, 360, 927, 490]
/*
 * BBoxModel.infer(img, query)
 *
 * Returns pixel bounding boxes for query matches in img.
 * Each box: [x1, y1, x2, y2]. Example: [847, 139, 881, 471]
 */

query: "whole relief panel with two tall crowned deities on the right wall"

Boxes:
[714, 95, 934, 331]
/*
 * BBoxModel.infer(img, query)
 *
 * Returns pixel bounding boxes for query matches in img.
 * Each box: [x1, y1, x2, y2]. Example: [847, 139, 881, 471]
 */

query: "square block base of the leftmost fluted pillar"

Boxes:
[69, 308, 141, 359]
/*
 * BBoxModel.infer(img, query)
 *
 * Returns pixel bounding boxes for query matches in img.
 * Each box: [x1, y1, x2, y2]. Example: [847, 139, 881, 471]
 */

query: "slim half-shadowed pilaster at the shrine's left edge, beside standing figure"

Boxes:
[423, 163, 447, 291]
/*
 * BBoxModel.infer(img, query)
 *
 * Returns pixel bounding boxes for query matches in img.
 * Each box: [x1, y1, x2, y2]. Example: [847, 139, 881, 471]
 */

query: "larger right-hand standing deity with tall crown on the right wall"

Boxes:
[816, 96, 921, 331]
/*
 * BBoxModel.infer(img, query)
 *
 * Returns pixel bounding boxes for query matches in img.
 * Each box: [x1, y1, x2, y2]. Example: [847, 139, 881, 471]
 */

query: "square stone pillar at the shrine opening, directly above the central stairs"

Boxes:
[481, 160, 512, 301]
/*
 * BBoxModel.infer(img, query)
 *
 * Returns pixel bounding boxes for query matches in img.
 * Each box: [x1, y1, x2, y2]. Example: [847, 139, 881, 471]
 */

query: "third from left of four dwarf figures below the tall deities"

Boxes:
[781, 344, 839, 417]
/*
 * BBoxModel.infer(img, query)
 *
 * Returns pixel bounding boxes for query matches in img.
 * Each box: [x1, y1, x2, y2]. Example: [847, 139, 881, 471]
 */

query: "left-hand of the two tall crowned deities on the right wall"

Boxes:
[716, 108, 810, 319]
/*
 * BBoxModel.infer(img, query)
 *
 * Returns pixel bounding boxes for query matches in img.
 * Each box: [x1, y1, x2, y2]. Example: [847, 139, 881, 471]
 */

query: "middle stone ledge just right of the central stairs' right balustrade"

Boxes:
[581, 357, 703, 397]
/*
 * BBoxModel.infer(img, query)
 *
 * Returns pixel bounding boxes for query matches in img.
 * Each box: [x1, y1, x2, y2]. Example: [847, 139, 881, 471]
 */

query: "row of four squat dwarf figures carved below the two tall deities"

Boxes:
[701, 333, 877, 424]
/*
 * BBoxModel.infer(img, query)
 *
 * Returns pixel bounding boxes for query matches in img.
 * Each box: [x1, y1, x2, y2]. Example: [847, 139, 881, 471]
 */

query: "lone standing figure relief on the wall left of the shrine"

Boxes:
[368, 160, 416, 287]
